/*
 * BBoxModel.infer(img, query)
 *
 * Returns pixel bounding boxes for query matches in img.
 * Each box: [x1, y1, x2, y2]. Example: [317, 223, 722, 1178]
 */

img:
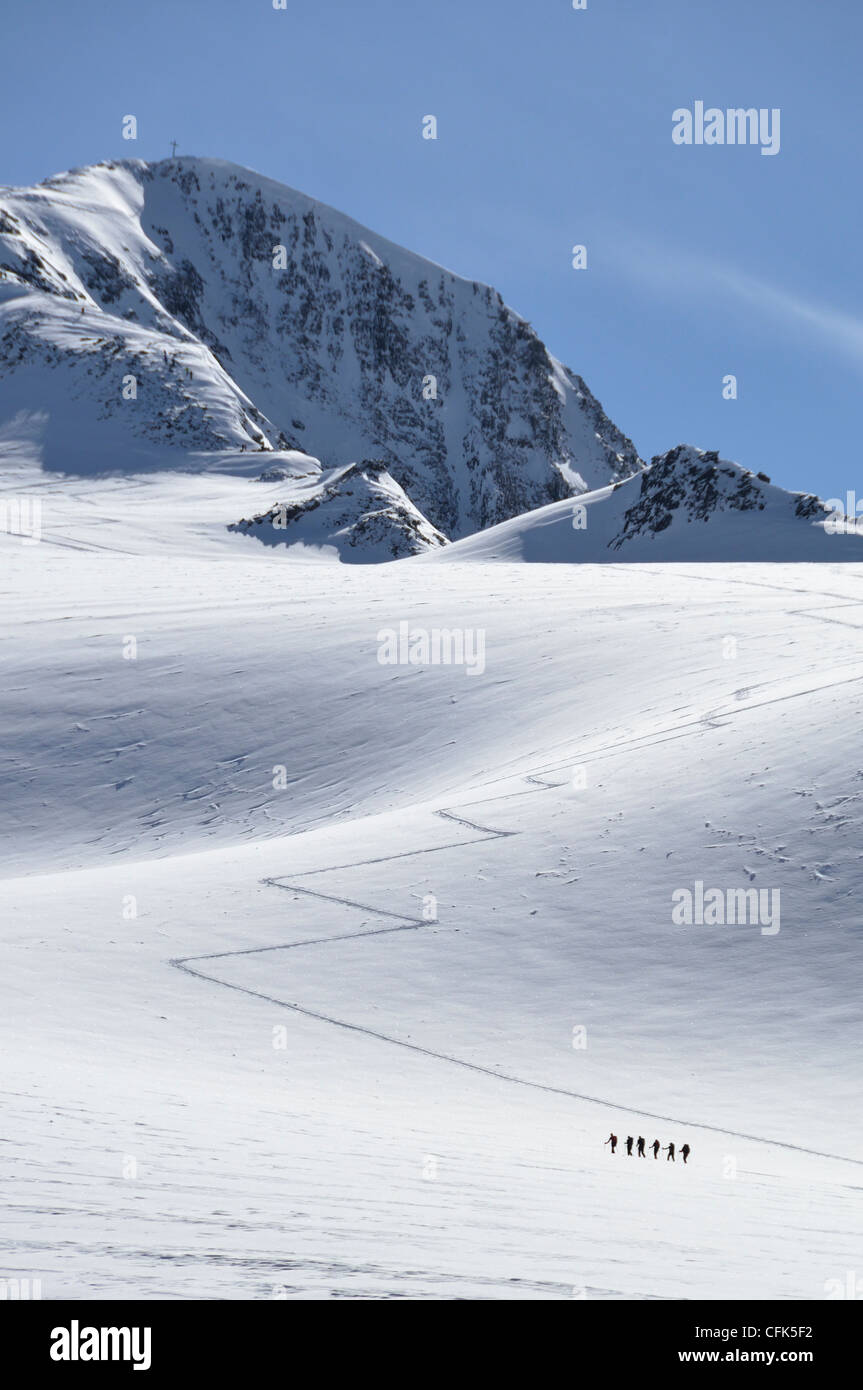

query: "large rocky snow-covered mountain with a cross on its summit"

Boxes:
[0, 158, 642, 538]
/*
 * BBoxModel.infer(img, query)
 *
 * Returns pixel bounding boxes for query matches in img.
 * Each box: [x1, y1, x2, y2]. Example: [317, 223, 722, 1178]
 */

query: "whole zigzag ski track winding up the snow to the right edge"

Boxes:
[168, 653, 863, 1166]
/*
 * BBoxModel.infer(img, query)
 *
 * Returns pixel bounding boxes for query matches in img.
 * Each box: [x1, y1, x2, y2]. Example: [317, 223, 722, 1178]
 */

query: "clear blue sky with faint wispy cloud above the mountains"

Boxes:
[0, 0, 863, 498]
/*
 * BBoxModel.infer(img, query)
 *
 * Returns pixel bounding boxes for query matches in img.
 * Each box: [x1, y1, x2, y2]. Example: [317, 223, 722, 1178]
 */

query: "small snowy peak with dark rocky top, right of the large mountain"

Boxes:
[430, 445, 863, 564]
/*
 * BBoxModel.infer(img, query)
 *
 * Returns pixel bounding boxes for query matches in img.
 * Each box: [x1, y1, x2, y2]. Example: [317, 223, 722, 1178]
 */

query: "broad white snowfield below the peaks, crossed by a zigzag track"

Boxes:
[0, 461, 863, 1300]
